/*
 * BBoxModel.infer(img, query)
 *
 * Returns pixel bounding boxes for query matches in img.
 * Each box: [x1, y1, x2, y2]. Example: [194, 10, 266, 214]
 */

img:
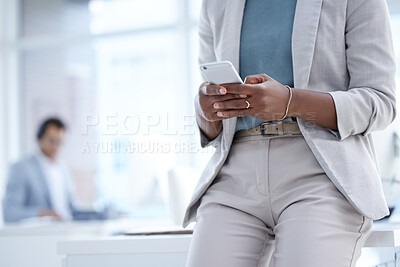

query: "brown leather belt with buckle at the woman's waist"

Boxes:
[235, 120, 301, 137]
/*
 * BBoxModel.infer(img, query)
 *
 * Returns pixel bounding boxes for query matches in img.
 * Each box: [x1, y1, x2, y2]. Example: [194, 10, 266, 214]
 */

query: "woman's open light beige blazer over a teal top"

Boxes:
[183, 0, 396, 226]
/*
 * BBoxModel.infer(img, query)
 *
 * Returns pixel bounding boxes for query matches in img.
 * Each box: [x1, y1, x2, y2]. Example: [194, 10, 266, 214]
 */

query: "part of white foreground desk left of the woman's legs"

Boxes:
[58, 235, 192, 267]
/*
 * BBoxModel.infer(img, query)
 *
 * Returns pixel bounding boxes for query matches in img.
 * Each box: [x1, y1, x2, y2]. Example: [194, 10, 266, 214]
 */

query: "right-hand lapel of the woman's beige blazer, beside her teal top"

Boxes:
[292, 0, 322, 89]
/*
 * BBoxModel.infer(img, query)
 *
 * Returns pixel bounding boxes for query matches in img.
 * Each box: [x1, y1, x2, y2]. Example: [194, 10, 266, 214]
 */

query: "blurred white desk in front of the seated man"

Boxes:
[0, 219, 169, 267]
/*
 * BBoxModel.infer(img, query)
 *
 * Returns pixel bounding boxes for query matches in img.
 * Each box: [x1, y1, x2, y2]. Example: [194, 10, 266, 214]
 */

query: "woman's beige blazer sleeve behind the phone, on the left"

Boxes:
[197, 0, 222, 148]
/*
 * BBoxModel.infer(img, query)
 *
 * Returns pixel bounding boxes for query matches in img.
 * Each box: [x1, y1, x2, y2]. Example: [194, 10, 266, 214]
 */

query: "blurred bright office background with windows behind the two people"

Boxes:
[0, 0, 400, 228]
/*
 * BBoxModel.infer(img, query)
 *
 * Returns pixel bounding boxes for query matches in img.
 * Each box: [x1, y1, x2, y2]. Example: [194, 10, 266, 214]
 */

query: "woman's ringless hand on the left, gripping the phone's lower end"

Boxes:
[195, 82, 247, 122]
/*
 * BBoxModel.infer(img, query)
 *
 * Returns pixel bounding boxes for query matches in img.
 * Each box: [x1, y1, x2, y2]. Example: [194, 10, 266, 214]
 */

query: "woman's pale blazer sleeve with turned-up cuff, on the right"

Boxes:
[329, 0, 396, 140]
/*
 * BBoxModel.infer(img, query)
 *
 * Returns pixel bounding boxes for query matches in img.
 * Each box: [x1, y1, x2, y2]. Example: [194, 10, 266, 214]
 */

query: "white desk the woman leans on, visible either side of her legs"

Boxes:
[58, 224, 400, 267]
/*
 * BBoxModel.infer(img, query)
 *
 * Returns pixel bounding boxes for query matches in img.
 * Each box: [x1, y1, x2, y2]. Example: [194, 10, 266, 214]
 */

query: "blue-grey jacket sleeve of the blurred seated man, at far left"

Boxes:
[3, 164, 39, 223]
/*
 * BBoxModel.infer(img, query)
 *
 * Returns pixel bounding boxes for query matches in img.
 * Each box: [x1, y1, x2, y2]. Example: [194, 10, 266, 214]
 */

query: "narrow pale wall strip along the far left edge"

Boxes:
[0, 0, 21, 226]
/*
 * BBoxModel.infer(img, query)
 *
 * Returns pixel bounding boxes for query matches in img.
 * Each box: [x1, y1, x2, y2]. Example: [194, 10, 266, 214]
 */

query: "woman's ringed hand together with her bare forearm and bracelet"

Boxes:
[214, 74, 338, 131]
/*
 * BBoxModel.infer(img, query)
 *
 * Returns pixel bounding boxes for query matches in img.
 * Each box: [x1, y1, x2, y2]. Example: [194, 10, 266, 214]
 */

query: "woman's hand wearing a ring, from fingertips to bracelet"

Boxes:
[214, 74, 290, 121]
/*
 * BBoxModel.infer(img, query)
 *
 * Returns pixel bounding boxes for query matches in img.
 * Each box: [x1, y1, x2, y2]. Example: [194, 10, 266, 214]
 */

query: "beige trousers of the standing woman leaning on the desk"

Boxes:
[186, 135, 372, 267]
